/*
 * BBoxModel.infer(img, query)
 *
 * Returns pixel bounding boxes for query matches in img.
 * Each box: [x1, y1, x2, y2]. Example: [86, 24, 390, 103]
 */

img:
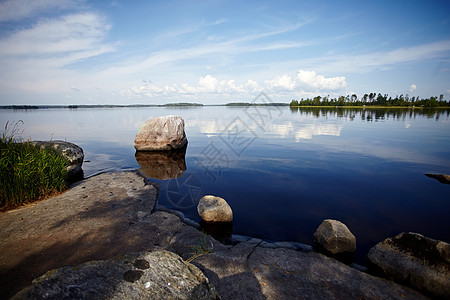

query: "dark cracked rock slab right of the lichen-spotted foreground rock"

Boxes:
[185, 242, 426, 299]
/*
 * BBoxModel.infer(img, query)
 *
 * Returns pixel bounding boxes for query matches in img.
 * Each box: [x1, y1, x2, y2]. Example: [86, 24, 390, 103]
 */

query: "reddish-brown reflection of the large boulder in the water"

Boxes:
[134, 147, 186, 179]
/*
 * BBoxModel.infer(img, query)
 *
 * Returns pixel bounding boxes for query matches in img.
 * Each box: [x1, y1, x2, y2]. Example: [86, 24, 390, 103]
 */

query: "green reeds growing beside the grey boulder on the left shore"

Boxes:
[0, 121, 69, 209]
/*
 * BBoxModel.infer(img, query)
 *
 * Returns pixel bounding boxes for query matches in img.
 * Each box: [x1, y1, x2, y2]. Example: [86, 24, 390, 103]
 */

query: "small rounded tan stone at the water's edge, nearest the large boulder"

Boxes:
[197, 195, 233, 222]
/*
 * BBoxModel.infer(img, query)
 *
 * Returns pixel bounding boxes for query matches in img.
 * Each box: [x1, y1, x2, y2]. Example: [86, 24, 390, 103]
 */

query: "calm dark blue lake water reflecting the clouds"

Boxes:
[0, 106, 450, 263]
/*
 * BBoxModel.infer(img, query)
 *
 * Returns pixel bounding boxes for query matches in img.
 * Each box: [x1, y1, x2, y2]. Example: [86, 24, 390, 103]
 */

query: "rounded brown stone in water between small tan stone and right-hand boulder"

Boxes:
[313, 219, 356, 254]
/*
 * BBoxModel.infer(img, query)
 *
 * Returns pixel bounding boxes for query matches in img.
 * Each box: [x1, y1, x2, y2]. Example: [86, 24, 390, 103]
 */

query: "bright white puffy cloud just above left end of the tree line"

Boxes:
[297, 70, 347, 91]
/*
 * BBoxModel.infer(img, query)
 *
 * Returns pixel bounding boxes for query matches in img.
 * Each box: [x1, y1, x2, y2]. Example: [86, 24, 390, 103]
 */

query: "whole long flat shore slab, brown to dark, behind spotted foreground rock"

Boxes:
[0, 172, 426, 299]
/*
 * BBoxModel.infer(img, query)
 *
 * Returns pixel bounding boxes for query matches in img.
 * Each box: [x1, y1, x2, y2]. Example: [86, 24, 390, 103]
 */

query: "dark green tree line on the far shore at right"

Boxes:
[290, 93, 450, 107]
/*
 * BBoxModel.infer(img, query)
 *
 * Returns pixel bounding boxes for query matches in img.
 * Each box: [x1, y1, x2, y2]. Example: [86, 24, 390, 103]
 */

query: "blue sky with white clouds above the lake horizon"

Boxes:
[0, 0, 450, 105]
